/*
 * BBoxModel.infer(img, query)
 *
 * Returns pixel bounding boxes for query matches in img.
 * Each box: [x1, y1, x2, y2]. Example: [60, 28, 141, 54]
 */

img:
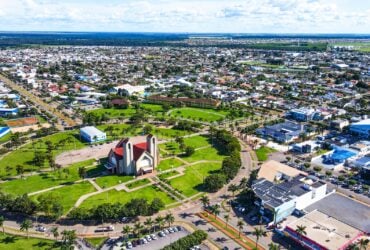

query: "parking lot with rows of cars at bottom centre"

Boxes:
[101, 227, 208, 250]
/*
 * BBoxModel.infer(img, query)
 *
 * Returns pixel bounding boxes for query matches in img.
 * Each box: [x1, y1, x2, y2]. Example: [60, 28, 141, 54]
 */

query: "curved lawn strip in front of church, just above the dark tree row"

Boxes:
[81, 186, 175, 208]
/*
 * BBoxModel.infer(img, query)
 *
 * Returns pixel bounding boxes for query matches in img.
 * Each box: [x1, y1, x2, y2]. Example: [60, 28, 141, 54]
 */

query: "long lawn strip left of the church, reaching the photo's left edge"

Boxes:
[0, 160, 95, 195]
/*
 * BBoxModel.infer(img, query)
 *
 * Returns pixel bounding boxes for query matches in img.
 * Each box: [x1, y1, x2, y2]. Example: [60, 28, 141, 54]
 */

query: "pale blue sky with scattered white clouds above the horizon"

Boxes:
[0, 0, 370, 33]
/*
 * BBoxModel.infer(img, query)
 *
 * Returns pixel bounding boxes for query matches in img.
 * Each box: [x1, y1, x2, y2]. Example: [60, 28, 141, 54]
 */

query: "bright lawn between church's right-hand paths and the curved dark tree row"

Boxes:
[170, 163, 221, 197]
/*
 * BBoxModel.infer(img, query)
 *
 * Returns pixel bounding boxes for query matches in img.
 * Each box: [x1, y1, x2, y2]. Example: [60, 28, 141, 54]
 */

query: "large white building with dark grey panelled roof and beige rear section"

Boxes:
[252, 161, 327, 223]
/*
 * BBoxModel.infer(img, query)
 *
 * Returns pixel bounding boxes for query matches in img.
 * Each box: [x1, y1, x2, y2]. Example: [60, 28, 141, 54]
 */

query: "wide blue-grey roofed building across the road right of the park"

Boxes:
[256, 121, 306, 143]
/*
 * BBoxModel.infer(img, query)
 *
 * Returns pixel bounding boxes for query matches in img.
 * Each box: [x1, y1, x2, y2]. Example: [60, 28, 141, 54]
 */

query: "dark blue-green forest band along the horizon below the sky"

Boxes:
[0, 32, 352, 51]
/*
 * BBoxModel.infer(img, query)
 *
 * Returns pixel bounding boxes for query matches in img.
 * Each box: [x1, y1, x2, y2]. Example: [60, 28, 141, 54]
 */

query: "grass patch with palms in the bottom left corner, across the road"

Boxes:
[0, 233, 60, 250]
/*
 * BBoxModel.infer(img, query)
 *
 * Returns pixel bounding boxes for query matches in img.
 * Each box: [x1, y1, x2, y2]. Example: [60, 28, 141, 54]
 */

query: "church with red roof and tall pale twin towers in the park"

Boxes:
[106, 135, 158, 175]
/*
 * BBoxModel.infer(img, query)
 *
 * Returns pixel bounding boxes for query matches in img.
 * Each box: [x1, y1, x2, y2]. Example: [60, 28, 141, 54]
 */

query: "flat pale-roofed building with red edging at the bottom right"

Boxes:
[284, 210, 363, 250]
